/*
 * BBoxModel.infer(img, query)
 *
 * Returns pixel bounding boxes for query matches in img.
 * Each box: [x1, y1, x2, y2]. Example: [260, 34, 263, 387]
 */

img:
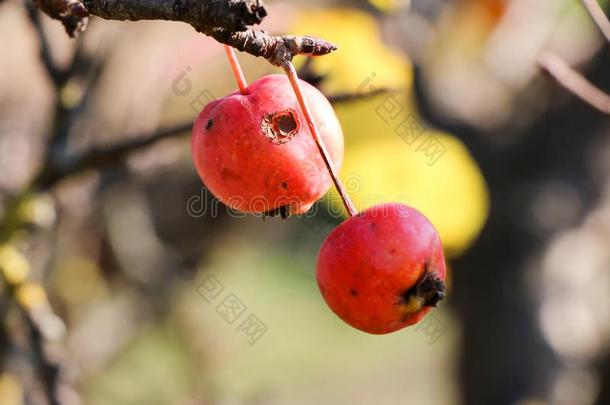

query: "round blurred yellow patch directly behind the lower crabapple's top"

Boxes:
[332, 128, 489, 256]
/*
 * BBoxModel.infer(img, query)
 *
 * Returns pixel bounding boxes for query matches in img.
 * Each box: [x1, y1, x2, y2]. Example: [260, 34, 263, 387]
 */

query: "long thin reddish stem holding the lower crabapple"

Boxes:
[283, 62, 357, 217]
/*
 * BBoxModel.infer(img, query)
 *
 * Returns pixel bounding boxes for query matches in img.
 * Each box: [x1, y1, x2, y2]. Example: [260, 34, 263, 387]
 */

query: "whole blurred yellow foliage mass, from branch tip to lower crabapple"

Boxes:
[293, 7, 489, 255]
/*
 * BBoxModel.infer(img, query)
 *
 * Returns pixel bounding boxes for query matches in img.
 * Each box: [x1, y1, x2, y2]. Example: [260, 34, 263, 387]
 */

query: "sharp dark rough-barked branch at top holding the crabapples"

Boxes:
[34, 0, 337, 67]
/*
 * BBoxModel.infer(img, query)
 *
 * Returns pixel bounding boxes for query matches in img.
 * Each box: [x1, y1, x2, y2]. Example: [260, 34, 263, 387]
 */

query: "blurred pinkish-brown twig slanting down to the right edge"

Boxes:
[538, 52, 610, 114]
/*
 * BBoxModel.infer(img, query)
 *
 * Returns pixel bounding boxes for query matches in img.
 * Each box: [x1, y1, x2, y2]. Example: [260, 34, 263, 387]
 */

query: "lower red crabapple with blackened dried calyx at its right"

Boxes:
[317, 203, 445, 334]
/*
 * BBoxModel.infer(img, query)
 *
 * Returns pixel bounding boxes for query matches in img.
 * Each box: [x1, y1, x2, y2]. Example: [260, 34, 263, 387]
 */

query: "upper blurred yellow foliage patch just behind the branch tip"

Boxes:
[292, 8, 413, 94]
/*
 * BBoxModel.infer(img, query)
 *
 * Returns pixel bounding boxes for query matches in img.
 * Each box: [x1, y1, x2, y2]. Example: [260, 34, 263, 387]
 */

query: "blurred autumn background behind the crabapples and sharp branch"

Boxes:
[0, 0, 610, 405]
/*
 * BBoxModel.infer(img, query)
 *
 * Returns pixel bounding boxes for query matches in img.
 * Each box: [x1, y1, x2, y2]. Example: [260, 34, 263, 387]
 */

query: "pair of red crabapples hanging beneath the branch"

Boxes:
[191, 75, 445, 334]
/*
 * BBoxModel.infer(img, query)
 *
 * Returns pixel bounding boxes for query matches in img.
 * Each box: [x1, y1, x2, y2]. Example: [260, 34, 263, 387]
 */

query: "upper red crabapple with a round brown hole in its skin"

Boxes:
[191, 75, 343, 215]
